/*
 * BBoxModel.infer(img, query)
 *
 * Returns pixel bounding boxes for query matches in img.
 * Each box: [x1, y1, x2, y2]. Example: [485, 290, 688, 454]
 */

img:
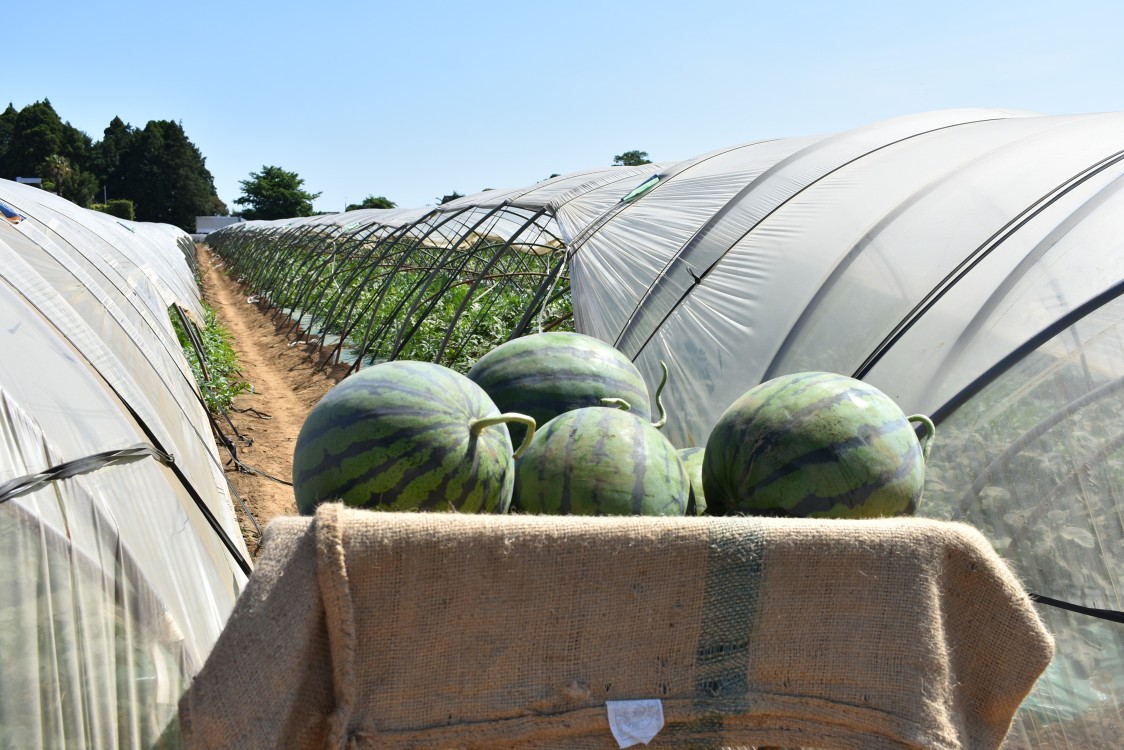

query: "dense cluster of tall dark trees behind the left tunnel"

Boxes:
[0, 99, 223, 232]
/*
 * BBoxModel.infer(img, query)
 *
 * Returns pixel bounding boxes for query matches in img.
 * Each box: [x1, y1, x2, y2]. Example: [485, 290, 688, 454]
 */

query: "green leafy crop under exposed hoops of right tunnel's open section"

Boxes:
[208, 219, 572, 382]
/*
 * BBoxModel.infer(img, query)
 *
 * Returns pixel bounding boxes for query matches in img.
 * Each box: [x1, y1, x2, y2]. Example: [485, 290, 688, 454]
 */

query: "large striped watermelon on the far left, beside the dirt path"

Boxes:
[293, 360, 515, 515]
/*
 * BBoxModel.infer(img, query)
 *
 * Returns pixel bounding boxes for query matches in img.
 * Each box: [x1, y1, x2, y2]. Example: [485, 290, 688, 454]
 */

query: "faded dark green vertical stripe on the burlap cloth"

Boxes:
[661, 518, 765, 748]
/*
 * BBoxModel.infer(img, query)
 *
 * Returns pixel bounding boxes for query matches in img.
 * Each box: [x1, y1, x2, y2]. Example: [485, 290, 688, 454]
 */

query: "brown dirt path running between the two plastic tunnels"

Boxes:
[197, 245, 344, 557]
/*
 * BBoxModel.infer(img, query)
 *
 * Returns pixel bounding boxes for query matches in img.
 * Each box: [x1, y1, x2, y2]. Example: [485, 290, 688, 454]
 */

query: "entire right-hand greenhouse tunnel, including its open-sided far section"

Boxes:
[211, 109, 1124, 748]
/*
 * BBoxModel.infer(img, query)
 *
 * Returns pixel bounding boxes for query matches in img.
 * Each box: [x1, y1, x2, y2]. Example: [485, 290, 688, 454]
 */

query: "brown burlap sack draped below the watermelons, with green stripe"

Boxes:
[180, 505, 1053, 749]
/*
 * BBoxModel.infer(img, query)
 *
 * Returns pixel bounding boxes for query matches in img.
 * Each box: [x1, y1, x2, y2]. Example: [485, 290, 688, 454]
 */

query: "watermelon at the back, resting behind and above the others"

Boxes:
[468, 332, 652, 445]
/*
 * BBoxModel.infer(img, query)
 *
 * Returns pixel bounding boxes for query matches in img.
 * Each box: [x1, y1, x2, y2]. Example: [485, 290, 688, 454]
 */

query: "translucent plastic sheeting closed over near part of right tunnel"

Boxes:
[560, 110, 1124, 748]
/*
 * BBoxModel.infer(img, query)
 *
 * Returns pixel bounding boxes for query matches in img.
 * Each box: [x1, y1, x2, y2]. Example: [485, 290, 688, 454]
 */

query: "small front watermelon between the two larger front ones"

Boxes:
[515, 406, 690, 516]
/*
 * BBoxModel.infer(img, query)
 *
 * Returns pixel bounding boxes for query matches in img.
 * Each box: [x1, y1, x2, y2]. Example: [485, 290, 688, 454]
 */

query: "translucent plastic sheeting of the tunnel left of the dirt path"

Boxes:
[0, 181, 248, 748]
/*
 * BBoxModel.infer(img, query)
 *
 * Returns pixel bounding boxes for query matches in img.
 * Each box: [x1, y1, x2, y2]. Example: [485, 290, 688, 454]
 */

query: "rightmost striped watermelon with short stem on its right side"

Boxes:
[703, 372, 933, 518]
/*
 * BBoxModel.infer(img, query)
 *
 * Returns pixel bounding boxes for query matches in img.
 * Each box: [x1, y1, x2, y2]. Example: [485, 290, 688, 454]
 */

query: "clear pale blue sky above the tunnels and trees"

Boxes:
[8, 0, 1124, 210]
